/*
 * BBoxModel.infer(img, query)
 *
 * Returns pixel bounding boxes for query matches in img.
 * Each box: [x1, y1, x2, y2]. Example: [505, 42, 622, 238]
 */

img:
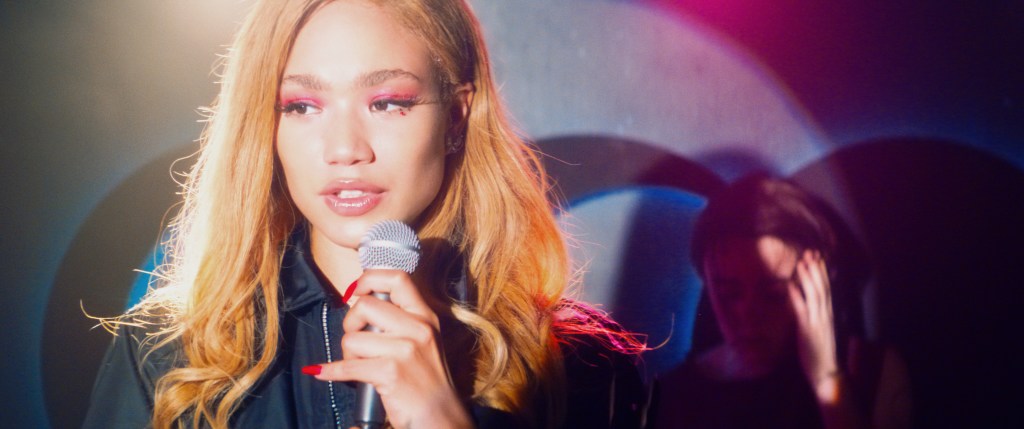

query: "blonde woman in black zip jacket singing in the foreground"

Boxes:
[85, 0, 644, 428]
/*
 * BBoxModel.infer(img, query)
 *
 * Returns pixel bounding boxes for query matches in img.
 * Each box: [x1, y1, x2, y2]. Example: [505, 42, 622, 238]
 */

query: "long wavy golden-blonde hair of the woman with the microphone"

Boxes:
[122, 0, 614, 429]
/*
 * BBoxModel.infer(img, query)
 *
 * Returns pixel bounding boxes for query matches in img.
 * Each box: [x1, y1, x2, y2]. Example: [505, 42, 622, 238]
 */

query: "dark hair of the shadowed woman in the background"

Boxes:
[690, 173, 869, 361]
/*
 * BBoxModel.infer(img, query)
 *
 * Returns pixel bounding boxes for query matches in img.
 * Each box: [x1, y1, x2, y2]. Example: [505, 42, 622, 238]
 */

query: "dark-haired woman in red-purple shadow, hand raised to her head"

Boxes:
[655, 175, 910, 429]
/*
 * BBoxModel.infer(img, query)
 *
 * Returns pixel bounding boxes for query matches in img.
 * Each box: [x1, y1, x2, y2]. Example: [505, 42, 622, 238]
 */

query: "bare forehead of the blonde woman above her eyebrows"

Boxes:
[285, 1, 433, 81]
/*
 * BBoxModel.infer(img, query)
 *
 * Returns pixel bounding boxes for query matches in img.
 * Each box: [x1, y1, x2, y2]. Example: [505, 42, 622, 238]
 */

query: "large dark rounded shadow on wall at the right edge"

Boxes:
[794, 138, 1024, 428]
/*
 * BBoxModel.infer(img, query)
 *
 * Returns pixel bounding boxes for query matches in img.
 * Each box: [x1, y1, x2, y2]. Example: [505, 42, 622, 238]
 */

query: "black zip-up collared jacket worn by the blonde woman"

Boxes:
[83, 243, 646, 429]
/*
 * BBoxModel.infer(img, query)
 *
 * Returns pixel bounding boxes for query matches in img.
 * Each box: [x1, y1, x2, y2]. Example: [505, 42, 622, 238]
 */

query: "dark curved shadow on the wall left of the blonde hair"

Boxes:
[40, 144, 194, 428]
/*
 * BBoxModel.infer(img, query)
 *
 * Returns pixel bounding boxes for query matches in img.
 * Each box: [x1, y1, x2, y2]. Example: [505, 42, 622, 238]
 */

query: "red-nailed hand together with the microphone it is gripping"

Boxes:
[307, 221, 472, 429]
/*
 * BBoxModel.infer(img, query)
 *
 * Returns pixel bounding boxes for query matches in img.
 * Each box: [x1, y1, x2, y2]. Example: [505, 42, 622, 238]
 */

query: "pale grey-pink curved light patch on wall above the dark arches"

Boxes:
[473, 0, 831, 178]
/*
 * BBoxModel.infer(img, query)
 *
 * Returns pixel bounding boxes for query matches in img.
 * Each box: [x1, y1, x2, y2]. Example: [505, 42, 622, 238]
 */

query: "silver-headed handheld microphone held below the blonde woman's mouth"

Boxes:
[355, 220, 420, 429]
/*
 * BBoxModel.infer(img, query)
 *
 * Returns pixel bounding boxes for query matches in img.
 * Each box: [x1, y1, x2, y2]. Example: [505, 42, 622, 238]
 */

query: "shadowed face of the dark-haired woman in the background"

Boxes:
[705, 235, 799, 368]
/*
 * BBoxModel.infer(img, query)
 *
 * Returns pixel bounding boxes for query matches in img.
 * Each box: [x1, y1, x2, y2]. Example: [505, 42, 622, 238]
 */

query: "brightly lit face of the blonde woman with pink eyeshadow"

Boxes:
[276, 1, 452, 248]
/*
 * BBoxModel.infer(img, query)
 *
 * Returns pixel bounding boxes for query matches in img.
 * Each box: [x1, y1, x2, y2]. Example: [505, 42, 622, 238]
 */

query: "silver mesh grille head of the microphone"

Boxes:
[359, 220, 420, 274]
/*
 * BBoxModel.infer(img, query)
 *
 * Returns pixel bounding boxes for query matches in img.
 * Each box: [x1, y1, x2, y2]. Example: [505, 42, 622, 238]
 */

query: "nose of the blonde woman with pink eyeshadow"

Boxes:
[321, 110, 374, 165]
